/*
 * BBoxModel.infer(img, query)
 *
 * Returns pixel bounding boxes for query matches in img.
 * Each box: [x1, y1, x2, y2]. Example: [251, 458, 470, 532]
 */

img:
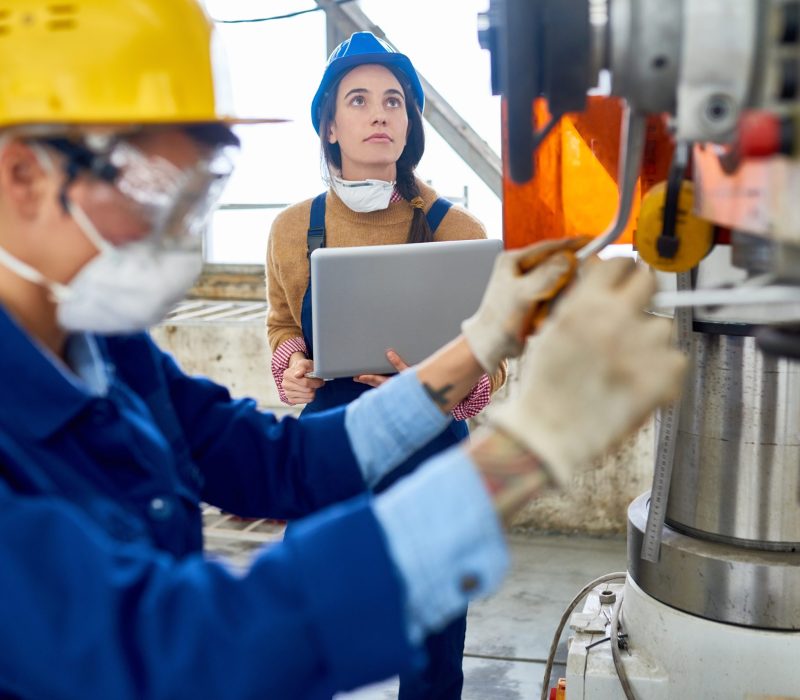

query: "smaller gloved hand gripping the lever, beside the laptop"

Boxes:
[461, 239, 580, 374]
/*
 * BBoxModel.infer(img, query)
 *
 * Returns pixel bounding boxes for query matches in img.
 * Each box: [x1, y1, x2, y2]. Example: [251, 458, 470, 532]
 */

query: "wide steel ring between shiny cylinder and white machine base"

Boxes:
[628, 493, 800, 630]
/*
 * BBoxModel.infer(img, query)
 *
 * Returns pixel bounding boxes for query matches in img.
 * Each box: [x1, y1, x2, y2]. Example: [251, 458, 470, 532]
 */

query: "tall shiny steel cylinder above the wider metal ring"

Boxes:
[667, 333, 800, 549]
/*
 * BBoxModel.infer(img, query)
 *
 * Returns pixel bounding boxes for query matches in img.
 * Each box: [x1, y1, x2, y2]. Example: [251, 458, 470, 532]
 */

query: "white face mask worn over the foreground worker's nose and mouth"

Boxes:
[0, 198, 203, 335]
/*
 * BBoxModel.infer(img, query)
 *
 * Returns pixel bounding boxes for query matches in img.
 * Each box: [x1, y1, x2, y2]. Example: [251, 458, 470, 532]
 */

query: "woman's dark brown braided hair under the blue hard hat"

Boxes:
[319, 66, 433, 243]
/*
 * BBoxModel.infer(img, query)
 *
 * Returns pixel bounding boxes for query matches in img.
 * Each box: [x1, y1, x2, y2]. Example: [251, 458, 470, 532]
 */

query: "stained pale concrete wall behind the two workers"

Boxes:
[153, 308, 653, 535]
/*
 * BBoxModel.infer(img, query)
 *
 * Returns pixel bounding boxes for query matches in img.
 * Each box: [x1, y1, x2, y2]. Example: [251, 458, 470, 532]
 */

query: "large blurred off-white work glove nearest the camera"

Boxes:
[488, 258, 686, 486]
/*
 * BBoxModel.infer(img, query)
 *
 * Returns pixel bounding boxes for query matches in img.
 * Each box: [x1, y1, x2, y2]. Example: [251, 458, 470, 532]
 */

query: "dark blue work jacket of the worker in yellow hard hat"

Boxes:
[0, 309, 418, 700]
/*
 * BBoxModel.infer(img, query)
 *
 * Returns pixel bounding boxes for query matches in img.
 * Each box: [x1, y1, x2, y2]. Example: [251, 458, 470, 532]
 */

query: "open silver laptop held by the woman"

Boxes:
[311, 240, 503, 379]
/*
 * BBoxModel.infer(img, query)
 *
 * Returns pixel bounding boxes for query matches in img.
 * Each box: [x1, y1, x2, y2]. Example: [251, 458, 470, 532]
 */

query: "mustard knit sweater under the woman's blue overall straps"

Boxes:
[266, 180, 505, 391]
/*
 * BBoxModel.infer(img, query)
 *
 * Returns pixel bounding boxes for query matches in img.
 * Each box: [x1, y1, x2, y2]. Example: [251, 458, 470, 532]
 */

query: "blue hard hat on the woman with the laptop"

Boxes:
[311, 32, 425, 133]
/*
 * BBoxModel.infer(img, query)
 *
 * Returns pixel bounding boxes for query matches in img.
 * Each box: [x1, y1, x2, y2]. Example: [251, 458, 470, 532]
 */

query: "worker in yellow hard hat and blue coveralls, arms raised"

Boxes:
[0, 0, 683, 700]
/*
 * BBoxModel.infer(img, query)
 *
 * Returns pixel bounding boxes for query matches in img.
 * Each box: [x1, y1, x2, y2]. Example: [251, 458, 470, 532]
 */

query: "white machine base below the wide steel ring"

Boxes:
[566, 576, 800, 700]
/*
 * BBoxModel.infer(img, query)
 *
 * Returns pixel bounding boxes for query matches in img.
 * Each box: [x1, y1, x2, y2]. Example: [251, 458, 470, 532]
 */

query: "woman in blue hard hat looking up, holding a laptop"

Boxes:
[267, 32, 505, 700]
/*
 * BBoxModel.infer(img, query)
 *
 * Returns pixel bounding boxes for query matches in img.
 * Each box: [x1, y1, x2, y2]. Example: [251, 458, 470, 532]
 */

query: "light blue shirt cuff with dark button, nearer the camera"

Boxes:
[373, 447, 509, 643]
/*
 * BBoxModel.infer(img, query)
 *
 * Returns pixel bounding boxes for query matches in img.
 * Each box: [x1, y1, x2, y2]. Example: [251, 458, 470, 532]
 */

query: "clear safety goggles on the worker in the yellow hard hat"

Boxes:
[42, 133, 233, 249]
